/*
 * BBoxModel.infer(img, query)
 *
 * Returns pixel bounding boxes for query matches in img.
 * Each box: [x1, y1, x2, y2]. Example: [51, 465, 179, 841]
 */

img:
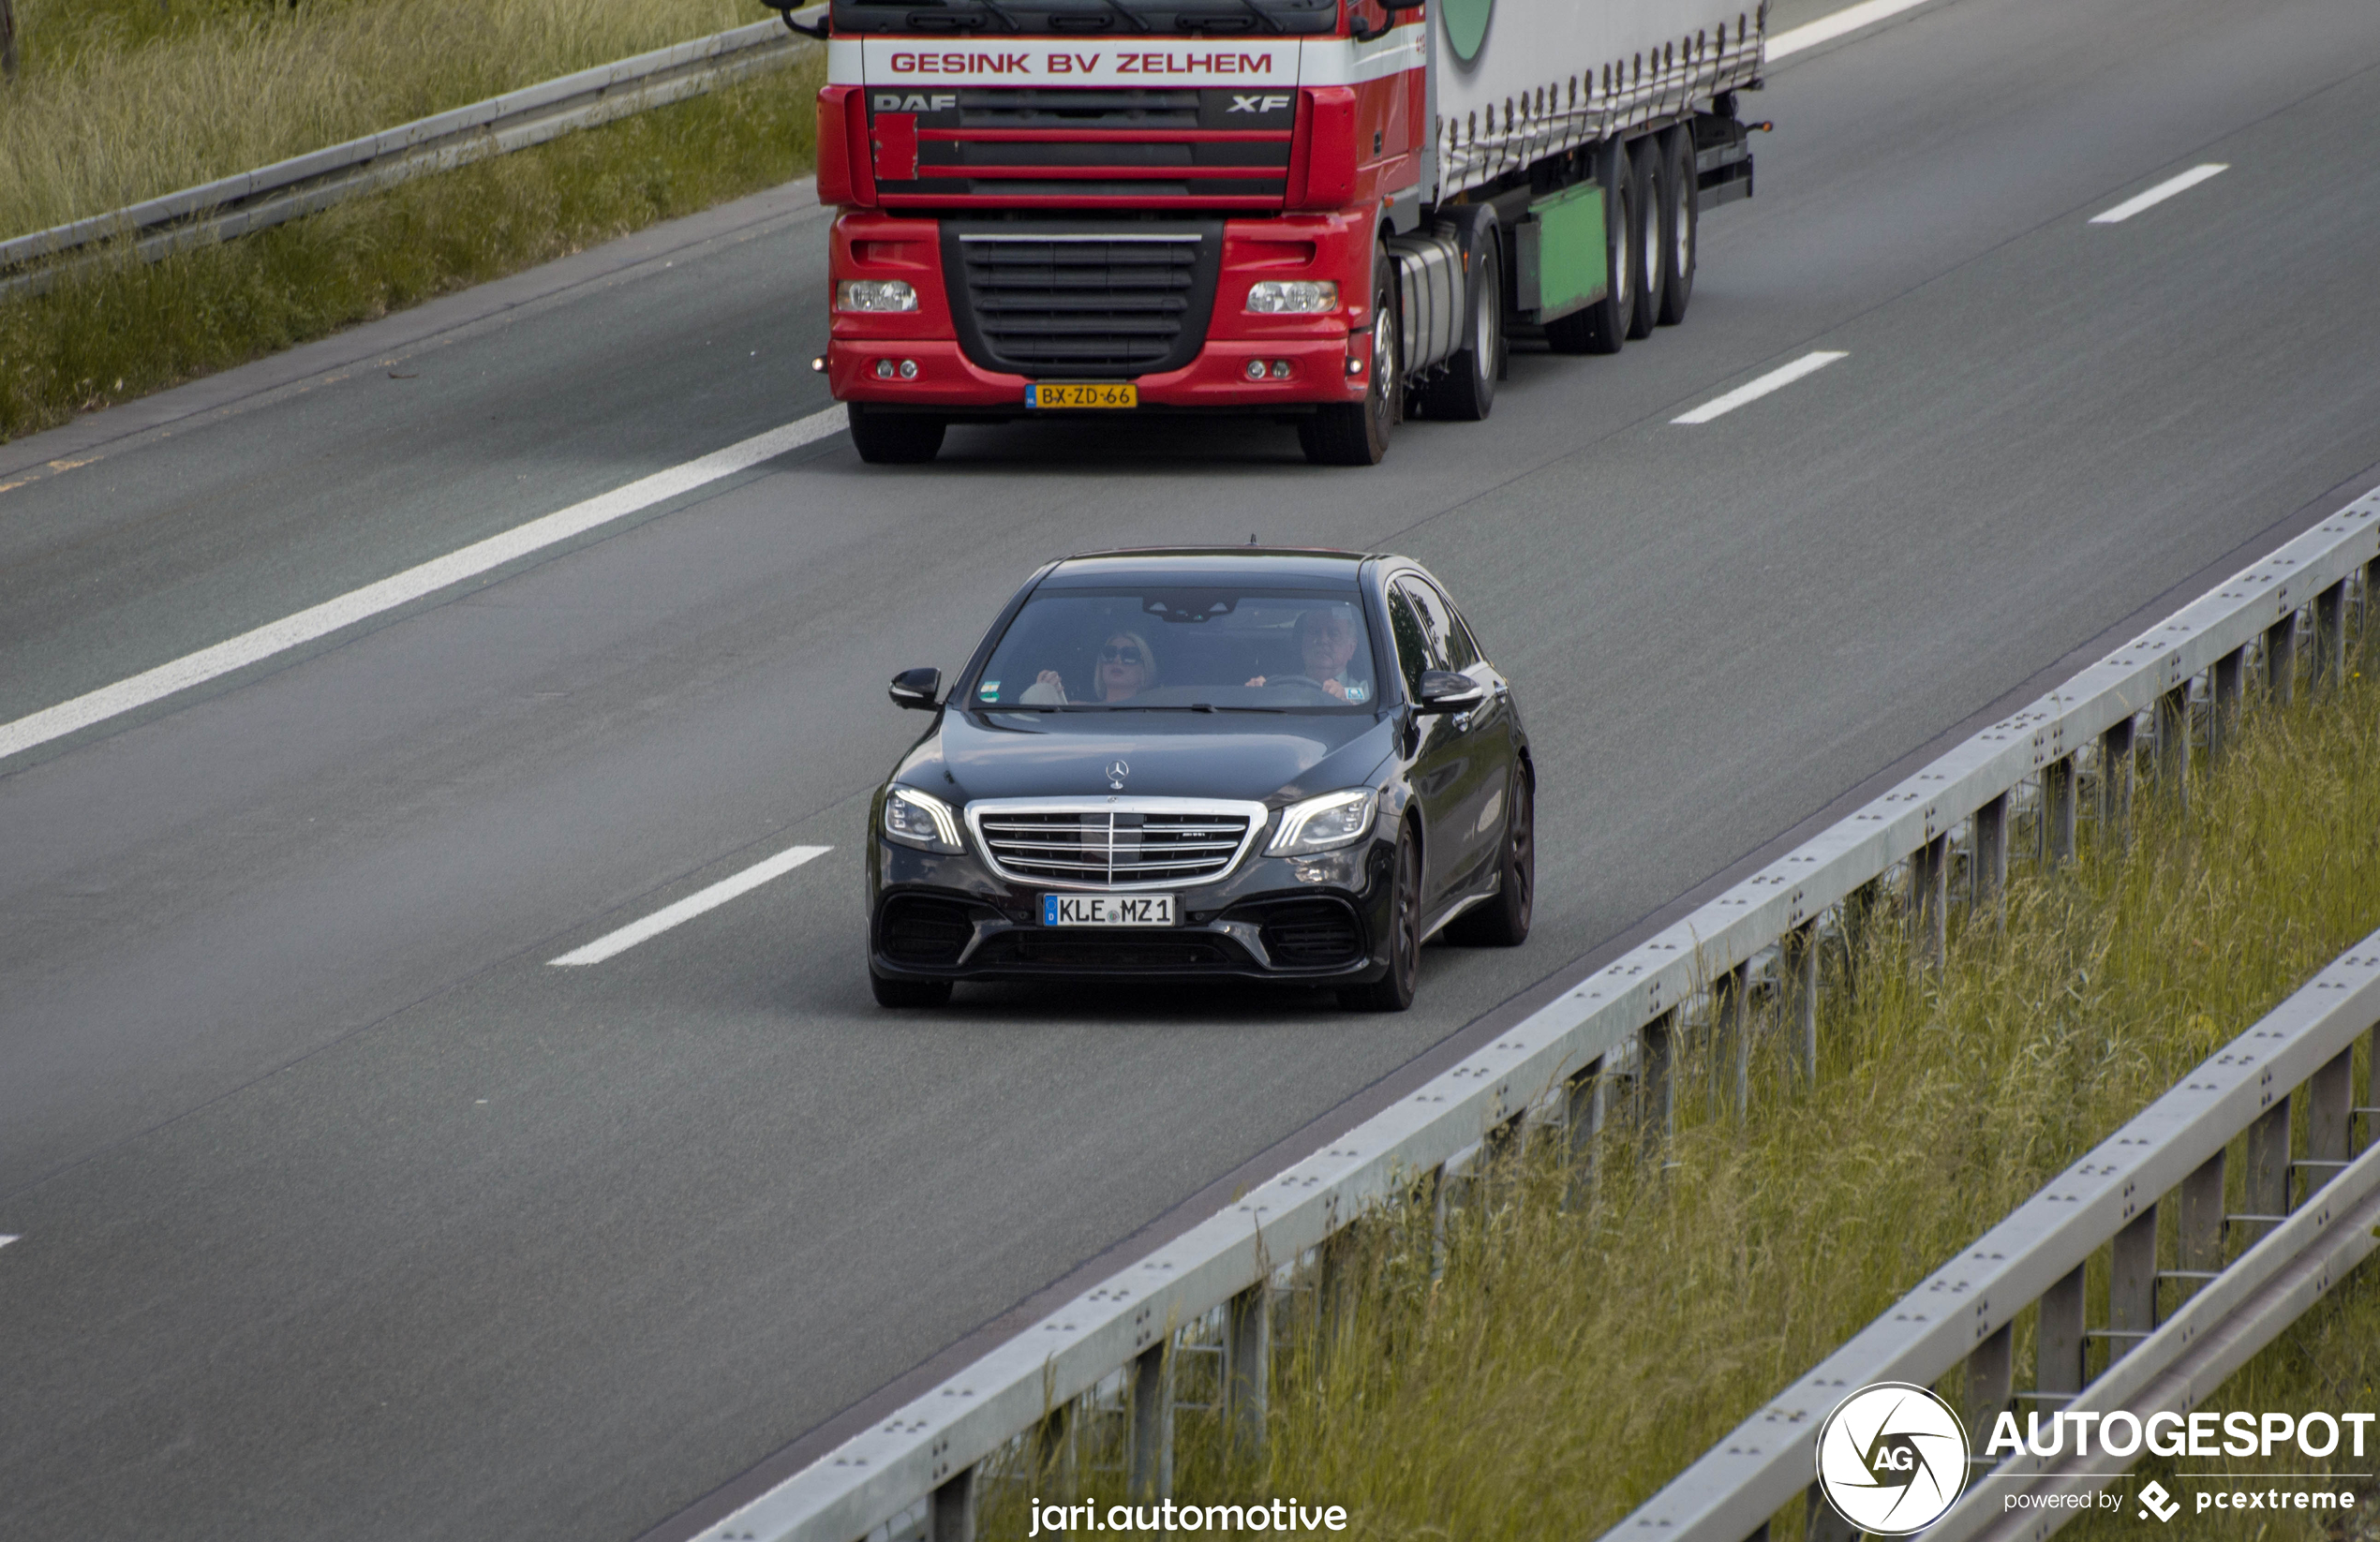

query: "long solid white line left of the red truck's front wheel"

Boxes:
[0, 405, 845, 759]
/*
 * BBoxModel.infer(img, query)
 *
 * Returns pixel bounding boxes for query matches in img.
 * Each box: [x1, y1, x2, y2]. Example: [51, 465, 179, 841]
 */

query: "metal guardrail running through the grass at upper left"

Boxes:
[0, 22, 819, 300]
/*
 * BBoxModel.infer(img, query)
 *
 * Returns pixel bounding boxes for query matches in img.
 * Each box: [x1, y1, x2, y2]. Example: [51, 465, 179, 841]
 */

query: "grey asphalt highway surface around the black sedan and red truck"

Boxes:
[0, 0, 2380, 1537]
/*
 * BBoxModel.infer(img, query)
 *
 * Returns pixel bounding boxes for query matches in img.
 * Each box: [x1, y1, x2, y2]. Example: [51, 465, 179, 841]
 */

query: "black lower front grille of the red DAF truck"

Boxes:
[943, 221, 1224, 376]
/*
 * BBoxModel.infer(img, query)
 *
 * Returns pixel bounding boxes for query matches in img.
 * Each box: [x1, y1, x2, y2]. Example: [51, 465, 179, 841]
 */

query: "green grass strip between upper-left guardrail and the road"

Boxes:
[0, 54, 824, 440]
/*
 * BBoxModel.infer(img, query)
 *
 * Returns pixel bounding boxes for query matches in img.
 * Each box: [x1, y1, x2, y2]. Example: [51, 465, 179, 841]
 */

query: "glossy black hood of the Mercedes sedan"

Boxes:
[893, 711, 1397, 805]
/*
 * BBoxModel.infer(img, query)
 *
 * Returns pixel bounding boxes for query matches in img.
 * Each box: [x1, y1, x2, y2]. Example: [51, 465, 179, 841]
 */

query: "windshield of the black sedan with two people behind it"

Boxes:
[974, 587, 1380, 711]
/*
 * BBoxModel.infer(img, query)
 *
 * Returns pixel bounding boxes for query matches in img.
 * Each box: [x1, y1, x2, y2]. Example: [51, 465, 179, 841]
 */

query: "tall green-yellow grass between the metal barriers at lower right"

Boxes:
[966, 651, 2380, 1542]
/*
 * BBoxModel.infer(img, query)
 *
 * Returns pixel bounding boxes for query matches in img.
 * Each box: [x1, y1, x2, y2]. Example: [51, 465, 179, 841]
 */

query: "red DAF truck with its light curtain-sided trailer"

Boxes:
[779, 0, 1766, 467]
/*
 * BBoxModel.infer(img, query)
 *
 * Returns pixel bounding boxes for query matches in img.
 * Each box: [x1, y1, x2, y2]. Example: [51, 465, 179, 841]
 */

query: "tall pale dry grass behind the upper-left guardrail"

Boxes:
[0, 0, 766, 238]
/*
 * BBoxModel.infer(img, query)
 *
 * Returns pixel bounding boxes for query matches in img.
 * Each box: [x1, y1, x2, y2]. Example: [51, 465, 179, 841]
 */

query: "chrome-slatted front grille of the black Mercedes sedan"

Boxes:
[966, 797, 1264, 890]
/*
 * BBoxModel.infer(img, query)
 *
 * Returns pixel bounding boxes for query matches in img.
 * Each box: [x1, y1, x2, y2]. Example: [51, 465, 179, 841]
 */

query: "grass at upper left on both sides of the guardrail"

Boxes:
[0, 0, 824, 440]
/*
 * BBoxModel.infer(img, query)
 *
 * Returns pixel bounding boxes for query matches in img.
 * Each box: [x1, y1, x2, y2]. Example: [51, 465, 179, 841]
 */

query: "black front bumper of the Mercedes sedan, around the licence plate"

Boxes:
[869, 836, 1394, 986]
